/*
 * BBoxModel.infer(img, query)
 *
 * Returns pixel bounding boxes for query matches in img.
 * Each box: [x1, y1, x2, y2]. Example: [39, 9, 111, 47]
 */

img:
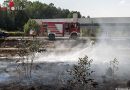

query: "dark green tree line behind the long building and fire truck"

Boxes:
[0, 0, 81, 31]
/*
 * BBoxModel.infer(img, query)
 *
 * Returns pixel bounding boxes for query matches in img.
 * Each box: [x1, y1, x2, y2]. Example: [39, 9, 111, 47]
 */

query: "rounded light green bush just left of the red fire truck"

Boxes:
[24, 19, 39, 34]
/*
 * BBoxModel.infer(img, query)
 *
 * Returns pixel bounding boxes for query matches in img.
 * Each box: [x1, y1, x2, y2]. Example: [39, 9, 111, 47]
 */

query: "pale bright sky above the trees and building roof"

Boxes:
[0, 0, 130, 17]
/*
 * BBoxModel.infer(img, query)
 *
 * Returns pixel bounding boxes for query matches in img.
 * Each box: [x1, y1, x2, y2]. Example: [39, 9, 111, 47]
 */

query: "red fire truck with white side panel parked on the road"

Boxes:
[41, 22, 80, 40]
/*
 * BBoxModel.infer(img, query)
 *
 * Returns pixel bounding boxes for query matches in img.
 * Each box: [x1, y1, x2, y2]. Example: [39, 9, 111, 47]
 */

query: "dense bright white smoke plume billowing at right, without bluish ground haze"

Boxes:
[32, 19, 130, 76]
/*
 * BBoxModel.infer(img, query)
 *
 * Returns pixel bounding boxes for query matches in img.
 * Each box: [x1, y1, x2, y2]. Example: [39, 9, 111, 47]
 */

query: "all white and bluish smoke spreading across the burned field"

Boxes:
[0, 20, 130, 90]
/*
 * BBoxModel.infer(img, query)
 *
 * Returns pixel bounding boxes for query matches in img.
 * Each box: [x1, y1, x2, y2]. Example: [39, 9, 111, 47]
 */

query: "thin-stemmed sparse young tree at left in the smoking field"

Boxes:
[16, 37, 43, 78]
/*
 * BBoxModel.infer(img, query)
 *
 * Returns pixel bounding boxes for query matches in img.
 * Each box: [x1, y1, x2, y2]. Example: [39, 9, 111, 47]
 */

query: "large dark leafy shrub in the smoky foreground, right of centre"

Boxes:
[68, 56, 97, 90]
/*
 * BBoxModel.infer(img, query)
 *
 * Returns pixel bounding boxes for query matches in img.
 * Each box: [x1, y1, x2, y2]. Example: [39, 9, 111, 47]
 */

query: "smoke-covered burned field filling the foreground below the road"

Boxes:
[0, 39, 130, 90]
